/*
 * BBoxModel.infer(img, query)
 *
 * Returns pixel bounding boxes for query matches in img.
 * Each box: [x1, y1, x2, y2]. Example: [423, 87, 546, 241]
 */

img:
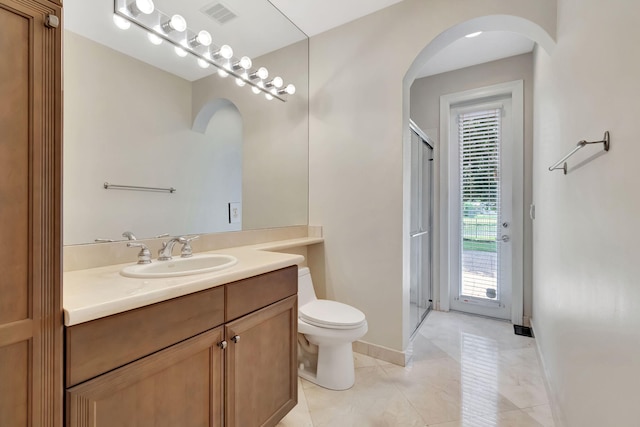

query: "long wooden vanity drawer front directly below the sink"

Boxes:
[66, 286, 225, 387]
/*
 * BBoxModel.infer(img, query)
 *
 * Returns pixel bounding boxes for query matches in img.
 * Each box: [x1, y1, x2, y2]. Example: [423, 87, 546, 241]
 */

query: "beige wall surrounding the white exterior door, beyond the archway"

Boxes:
[410, 53, 533, 318]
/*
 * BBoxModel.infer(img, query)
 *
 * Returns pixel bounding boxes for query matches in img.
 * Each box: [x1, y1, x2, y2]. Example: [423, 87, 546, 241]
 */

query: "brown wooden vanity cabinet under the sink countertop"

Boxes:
[66, 266, 298, 427]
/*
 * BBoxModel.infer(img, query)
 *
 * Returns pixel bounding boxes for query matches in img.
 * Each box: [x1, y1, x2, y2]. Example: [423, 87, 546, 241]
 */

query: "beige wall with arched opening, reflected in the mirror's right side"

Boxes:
[192, 40, 309, 230]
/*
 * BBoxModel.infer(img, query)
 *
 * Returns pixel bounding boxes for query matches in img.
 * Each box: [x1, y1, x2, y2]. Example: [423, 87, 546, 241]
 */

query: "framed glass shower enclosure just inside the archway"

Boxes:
[410, 120, 433, 331]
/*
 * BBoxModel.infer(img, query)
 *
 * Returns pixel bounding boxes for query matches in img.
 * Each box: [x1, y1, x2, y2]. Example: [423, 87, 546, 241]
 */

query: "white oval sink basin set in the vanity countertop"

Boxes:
[120, 254, 238, 279]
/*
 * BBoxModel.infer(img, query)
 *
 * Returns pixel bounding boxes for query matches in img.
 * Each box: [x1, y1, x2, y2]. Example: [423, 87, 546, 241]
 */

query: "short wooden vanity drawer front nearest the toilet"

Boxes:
[225, 265, 298, 322]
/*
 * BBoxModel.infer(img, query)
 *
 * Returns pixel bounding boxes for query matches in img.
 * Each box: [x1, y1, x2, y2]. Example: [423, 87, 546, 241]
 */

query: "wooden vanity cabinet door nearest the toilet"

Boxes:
[225, 296, 298, 427]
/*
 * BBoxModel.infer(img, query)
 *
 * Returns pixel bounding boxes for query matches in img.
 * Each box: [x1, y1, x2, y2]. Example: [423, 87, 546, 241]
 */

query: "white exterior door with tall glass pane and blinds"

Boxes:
[449, 97, 522, 319]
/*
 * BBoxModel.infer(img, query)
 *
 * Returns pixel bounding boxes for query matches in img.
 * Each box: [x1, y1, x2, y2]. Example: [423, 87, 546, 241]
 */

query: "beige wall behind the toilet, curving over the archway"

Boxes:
[309, 0, 556, 350]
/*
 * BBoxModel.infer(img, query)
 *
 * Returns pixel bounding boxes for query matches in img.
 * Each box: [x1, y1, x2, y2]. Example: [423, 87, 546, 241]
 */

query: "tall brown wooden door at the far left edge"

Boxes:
[0, 0, 63, 427]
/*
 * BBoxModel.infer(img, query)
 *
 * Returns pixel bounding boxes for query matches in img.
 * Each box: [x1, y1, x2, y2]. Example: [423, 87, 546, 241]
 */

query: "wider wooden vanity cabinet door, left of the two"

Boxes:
[67, 327, 224, 427]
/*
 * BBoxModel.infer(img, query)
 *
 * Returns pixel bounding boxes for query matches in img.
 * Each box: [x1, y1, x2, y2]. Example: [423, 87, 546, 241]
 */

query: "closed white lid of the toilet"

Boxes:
[298, 300, 366, 329]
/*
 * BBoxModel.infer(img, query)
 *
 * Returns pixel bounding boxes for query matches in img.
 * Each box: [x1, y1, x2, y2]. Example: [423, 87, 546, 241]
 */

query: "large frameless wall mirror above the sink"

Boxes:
[63, 0, 309, 245]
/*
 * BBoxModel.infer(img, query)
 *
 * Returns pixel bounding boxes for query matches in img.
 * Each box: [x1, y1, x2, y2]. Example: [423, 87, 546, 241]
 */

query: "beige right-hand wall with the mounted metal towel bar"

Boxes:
[533, 0, 640, 427]
